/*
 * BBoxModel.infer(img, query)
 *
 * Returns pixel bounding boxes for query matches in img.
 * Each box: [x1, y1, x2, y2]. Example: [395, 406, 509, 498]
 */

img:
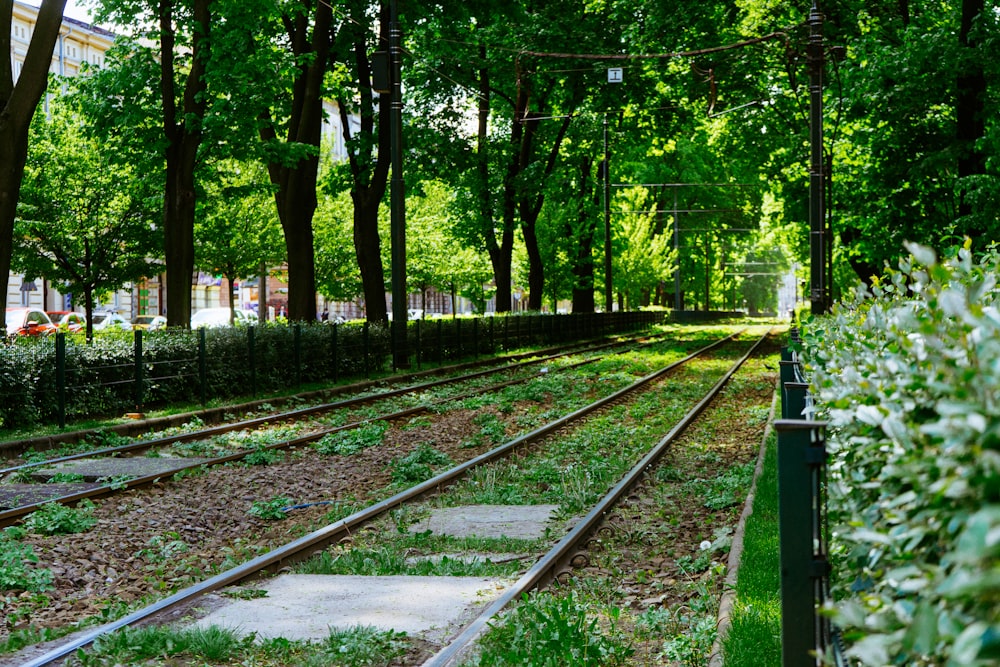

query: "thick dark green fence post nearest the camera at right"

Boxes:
[774, 419, 829, 667]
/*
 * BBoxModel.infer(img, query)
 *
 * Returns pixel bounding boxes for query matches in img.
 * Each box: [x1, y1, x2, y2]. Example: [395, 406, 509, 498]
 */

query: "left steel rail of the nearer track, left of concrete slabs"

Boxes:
[15, 332, 744, 667]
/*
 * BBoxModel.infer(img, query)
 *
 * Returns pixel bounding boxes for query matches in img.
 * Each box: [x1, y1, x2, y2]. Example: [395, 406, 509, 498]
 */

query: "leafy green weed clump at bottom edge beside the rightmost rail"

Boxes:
[476, 593, 633, 667]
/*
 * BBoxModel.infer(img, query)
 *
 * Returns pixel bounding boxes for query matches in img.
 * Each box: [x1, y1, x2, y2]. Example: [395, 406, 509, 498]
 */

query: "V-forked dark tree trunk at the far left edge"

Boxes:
[0, 0, 66, 308]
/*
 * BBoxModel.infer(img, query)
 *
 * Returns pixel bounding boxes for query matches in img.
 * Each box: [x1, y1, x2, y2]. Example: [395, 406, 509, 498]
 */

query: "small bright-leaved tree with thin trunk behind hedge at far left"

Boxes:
[14, 86, 162, 339]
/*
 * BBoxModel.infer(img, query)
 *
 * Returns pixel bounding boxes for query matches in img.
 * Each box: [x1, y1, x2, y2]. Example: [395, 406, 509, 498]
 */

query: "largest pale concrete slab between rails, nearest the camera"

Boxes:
[195, 574, 509, 642]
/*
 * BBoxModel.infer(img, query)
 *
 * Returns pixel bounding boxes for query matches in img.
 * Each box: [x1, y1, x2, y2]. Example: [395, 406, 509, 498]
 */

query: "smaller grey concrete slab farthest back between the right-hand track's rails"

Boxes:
[409, 505, 559, 540]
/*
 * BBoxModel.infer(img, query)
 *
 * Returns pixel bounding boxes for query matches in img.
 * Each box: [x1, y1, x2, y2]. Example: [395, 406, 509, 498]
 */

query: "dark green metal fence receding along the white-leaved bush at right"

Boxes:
[774, 329, 846, 667]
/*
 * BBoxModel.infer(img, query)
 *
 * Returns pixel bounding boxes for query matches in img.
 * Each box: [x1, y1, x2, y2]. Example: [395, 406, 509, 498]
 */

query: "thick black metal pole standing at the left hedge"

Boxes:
[389, 0, 409, 368]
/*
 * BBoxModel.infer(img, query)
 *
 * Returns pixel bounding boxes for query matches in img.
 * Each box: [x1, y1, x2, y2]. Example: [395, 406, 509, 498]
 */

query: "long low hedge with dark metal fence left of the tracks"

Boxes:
[0, 312, 664, 429]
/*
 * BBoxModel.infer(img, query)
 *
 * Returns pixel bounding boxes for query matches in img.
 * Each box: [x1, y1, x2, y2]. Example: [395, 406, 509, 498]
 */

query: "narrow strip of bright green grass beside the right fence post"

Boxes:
[723, 433, 781, 667]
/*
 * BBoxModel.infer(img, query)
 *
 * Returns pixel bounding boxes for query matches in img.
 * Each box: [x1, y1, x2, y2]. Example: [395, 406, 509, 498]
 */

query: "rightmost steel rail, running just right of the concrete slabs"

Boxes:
[422, 331, 771, 667]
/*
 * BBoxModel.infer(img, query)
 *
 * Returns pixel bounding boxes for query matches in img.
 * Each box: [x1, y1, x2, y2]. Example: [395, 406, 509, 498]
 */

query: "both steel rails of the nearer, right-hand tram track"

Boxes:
[3, 335, 767, 666]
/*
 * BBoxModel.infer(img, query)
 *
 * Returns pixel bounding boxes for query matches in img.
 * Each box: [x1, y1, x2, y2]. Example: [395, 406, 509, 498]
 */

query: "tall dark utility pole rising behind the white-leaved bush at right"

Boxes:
[806, 0, 830, 315]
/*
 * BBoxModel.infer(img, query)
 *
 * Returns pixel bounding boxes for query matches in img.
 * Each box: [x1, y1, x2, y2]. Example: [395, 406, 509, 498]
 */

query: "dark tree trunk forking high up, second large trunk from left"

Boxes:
[158, 0, 211, 327]
